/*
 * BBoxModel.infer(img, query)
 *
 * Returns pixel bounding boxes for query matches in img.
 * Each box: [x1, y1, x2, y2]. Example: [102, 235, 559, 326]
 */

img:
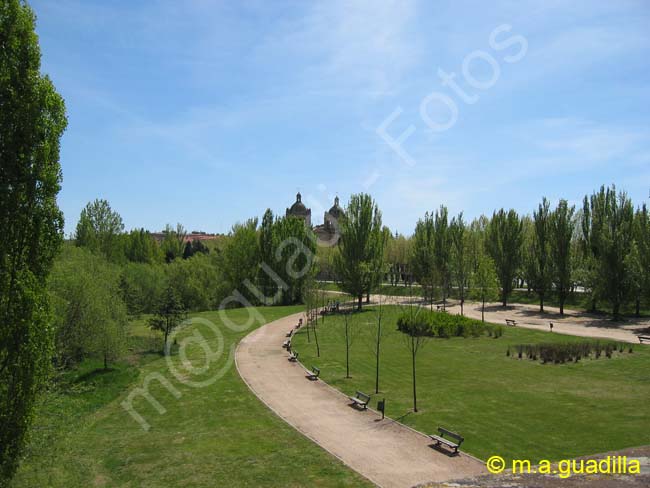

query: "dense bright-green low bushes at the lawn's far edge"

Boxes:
[397, 309, 503, 339]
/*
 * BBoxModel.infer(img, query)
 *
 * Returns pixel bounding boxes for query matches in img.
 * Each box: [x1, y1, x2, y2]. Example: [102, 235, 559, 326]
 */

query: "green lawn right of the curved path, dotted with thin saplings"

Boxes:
[293, 307, 650, 460]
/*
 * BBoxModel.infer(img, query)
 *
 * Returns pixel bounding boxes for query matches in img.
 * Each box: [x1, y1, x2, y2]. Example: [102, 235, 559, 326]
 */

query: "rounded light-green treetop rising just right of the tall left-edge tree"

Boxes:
[75, 200, 124, 262]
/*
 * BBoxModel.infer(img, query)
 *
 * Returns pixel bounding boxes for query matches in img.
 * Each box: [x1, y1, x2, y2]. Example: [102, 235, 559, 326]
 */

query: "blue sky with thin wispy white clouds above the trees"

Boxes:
[30, 0, 650, 234]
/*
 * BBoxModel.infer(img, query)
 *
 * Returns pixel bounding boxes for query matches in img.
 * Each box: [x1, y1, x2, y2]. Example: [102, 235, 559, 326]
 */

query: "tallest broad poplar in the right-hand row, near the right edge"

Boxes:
[583, 186, 634, 318]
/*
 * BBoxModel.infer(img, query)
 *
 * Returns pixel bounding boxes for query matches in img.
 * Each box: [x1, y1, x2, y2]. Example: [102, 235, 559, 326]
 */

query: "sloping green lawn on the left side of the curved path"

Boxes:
[13, 307, 370, 488]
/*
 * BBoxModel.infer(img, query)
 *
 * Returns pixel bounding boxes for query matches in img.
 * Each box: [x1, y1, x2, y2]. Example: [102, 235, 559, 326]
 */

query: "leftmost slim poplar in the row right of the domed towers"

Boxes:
[411, 212, 436, 303]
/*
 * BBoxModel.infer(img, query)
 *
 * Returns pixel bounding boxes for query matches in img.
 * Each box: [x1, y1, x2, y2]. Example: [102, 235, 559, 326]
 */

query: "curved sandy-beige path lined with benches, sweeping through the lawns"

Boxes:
[235, 314, 486, 487]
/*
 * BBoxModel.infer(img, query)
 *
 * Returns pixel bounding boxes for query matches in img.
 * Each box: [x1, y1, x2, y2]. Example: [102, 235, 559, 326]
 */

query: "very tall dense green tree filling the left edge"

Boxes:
[0, 0, 67, 480]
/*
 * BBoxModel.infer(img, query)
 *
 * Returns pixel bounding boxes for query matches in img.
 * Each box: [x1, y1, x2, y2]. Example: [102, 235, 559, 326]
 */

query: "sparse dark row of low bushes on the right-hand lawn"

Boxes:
[506, 341, 633, 364]
